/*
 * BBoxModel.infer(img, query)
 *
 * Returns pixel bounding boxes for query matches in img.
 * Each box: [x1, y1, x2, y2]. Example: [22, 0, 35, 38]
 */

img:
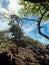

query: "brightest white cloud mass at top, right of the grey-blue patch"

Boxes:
[8, 0, 22, 14]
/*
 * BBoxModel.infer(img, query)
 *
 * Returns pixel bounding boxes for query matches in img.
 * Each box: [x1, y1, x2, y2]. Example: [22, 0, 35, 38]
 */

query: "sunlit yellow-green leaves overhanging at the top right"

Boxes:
[19, 0, 49, 20]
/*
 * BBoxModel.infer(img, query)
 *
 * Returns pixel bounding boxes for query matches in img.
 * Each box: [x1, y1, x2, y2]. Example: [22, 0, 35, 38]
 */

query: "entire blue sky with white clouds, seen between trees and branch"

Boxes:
[0, 0, 49, 44]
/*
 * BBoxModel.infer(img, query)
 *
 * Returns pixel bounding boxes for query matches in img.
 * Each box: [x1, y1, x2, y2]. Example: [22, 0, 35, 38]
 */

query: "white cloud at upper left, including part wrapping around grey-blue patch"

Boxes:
[0, 0, 23, 14]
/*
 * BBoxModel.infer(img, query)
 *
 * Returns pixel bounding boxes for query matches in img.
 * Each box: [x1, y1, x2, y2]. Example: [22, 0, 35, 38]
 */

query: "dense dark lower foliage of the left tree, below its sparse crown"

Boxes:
[9, 24, 23, 42]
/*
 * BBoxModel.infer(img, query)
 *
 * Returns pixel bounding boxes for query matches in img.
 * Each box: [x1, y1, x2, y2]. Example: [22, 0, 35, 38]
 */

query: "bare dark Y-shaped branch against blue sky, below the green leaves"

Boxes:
[23, 10, 49, 39]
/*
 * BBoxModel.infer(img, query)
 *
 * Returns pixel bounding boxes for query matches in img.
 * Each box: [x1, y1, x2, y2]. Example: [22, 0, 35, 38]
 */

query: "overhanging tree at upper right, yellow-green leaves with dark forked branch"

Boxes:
[19, 0, 49, 39]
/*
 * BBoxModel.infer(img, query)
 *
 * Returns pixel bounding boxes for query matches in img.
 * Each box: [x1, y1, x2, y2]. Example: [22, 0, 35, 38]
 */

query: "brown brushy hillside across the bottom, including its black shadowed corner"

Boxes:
[0, 40, 49, 65]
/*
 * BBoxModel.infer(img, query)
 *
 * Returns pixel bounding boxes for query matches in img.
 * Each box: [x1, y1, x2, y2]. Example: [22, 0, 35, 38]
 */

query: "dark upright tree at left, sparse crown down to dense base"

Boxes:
[9, 15, 23, 42]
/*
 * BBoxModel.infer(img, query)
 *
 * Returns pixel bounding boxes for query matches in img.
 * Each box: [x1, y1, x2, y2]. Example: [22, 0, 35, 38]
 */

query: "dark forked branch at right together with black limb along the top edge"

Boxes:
[24, 0, 49, 39]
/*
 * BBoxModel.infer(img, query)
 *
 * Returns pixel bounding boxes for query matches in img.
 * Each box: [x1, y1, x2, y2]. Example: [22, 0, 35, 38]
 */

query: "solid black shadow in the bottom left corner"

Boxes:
[0, 52, 16, 65]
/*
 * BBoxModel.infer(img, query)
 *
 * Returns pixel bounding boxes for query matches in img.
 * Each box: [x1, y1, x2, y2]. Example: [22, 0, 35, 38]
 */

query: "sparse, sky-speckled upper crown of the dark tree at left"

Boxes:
[9, 14, 22, 26]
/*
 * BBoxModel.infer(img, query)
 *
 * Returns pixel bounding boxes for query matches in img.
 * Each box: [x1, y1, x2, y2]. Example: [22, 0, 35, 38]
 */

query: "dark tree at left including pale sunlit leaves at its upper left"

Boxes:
[2, 9, 23, 42]
